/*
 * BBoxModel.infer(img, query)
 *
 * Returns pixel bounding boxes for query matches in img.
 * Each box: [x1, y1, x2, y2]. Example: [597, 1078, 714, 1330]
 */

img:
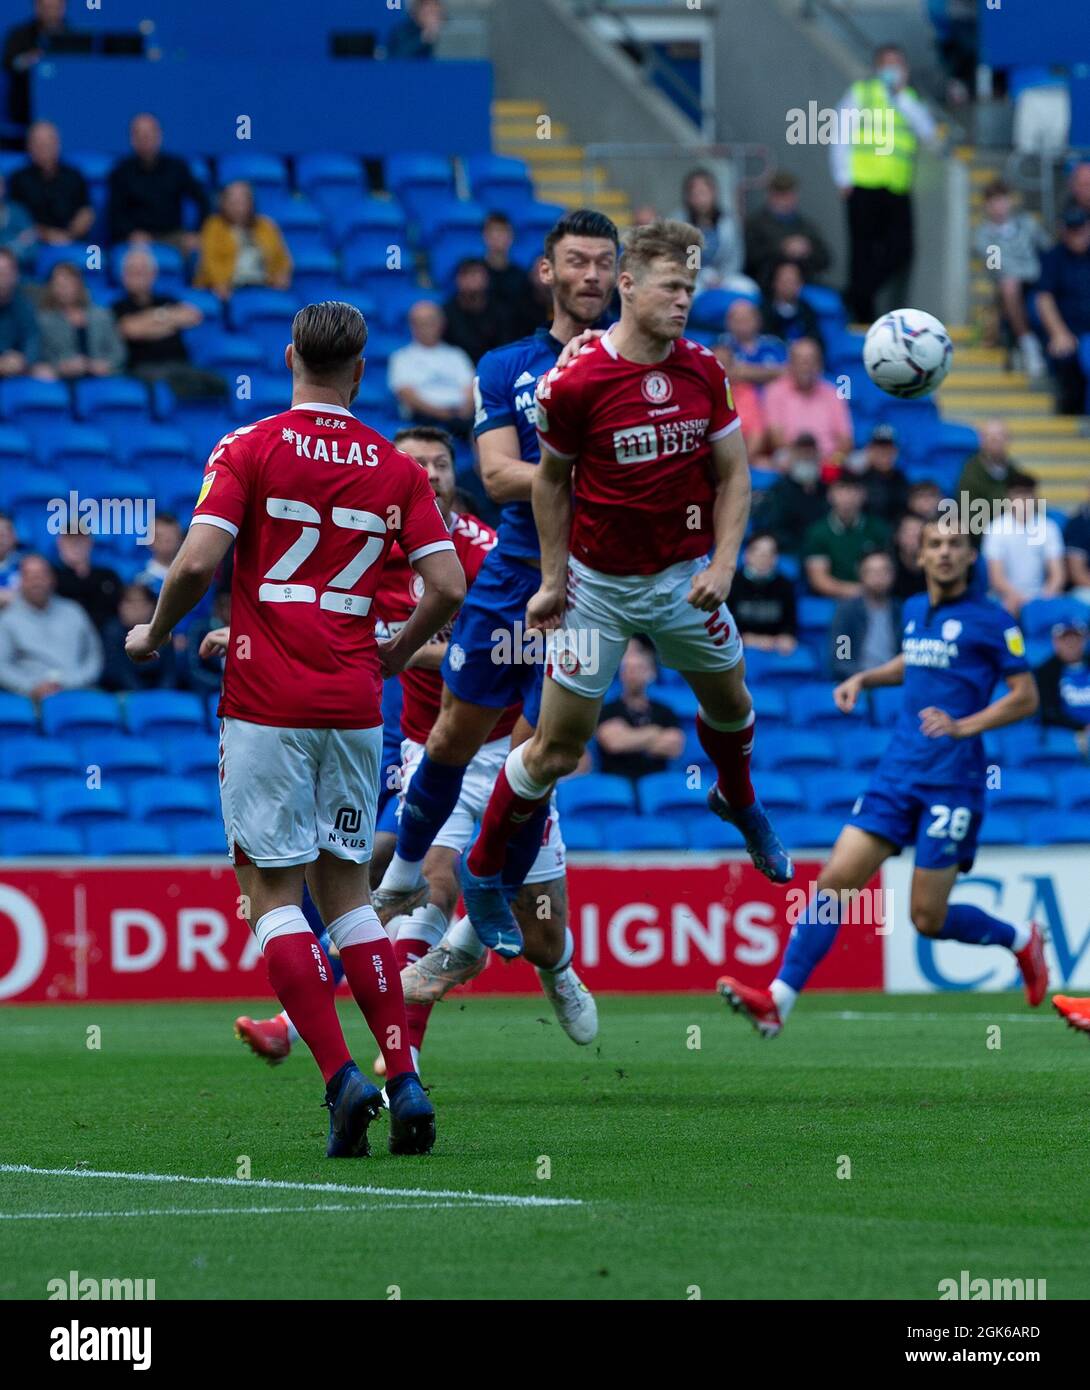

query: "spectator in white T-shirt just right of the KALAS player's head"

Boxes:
[387, 299, 474, 435]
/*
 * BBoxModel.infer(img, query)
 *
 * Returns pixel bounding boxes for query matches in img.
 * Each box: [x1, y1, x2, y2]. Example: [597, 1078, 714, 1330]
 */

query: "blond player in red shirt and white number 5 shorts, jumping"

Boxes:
[462, 222, 792, 955]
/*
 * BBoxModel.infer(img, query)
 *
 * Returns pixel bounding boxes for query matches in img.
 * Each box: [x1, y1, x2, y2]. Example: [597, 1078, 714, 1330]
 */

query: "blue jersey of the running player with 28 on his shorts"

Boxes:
[880, 592, 1029, 788]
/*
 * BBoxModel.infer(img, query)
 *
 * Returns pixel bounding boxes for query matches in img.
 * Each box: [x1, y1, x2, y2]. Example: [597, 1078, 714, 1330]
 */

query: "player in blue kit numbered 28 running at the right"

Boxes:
[717, 514, 1048, 1037]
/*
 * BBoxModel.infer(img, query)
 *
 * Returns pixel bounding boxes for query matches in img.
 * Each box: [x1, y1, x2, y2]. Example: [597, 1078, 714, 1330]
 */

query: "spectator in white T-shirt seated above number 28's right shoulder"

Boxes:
[980, 473, 1066, 617]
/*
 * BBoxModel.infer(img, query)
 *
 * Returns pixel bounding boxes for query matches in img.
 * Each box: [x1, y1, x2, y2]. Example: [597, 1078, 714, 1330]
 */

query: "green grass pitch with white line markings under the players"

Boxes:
[0, 992, 1090, 1300]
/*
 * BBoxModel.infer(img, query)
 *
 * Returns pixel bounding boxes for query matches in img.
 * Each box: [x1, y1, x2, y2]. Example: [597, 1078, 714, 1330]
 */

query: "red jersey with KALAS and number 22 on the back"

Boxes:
[193, 404, 453, 728]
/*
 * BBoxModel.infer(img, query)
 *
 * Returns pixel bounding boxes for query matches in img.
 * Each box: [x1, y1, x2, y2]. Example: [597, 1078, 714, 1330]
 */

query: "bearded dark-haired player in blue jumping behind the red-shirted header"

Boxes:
[371, 209, 617, 922]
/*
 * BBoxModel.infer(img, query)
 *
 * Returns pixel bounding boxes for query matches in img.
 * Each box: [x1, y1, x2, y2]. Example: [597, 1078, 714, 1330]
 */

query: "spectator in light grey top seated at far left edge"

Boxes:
[0, 555, 103, 699]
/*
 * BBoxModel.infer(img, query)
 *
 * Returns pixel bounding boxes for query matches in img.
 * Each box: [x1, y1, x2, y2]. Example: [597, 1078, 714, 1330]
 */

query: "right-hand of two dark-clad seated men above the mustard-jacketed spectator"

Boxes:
[108, 111, 209, 253]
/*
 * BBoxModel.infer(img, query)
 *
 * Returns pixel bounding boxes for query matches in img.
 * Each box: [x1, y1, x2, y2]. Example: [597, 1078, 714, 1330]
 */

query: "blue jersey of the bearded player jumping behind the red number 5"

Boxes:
[473, 328, 564, 560]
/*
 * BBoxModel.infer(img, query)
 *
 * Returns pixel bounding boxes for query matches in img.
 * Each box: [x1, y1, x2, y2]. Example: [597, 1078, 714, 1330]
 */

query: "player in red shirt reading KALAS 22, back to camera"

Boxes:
[125, 303, 464, 1158]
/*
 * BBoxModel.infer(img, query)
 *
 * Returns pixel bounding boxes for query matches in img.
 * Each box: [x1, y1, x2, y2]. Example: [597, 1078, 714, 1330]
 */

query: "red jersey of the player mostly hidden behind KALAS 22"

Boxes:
[375, 512, 521, 744]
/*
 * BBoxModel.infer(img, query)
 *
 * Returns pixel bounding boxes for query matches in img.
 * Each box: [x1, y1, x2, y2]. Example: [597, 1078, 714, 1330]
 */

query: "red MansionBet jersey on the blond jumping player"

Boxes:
[537, 334, 741, 574]
